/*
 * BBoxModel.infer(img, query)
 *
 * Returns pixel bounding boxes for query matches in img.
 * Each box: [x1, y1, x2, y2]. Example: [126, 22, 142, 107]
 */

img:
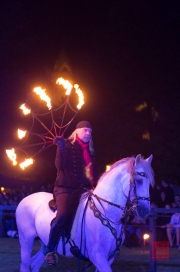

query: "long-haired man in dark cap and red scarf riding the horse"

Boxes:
[44, 121, 99, 265]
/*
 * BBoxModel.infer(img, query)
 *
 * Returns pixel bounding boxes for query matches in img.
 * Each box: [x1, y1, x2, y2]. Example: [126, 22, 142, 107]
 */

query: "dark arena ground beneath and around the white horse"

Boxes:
[0, 238, 180, 272]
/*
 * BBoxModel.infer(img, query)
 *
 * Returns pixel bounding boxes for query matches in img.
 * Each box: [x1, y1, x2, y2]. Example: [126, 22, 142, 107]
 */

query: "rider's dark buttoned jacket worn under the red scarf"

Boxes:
[55, 140, 99, 189]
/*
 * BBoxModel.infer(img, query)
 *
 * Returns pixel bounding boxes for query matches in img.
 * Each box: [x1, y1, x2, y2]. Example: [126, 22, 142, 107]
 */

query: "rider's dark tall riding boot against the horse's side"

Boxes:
[43, 222, 62, 265]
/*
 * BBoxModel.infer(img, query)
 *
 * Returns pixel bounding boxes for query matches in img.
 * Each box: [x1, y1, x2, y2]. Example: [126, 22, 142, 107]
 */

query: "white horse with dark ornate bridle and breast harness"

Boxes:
[16, 155, 154, 272]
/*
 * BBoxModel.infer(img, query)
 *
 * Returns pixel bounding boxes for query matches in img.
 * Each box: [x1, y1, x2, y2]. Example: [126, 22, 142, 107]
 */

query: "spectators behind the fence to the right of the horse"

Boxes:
[125, 179, 180, 249]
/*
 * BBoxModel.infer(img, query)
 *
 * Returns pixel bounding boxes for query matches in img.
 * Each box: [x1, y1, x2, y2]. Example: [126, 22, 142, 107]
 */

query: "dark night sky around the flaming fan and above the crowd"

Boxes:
[0, 0, 180, 185]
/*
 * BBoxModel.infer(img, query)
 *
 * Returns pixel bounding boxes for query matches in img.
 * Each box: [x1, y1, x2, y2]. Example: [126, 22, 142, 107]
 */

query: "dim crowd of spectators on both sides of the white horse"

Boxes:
[0, 180, 180, 246]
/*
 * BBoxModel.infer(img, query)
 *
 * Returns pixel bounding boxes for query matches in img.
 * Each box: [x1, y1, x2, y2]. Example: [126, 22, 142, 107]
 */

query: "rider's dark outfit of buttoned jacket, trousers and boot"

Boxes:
[44, 121, 99, 263]
